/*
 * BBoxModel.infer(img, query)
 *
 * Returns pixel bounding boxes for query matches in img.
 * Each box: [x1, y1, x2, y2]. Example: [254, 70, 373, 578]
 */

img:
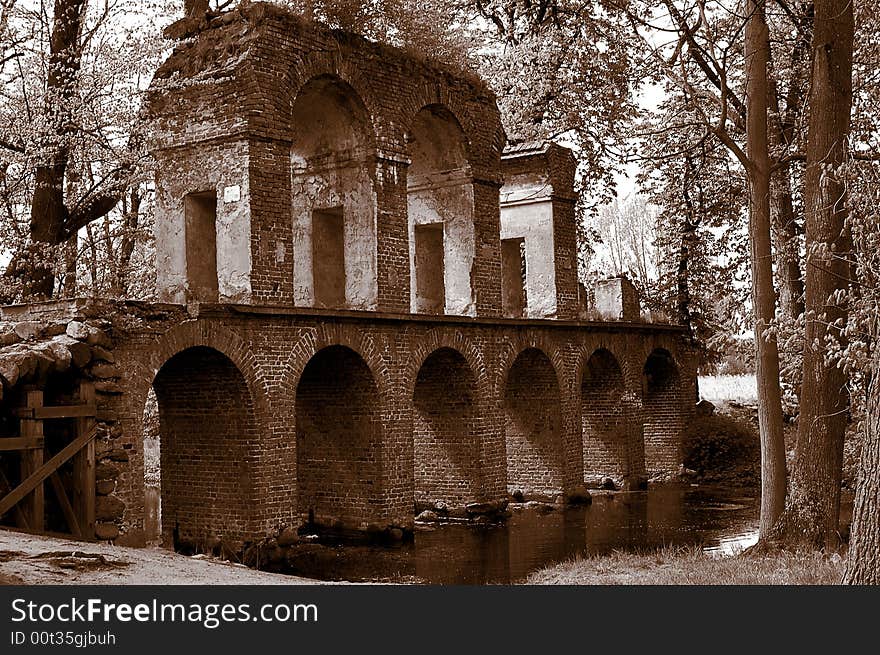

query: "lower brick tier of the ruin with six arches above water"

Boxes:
[4, 303, 693, 548]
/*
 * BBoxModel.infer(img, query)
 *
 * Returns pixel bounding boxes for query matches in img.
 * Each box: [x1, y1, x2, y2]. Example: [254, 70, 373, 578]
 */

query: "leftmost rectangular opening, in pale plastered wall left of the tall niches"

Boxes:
[184, 191, 219, 302]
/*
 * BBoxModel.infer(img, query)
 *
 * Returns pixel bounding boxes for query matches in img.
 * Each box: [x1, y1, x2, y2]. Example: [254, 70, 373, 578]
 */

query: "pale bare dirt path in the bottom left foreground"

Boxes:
[0, 529, 327, 585]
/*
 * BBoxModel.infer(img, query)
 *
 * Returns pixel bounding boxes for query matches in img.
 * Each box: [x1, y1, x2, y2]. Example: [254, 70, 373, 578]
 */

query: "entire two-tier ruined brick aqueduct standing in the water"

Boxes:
[3, 3, 696, 544]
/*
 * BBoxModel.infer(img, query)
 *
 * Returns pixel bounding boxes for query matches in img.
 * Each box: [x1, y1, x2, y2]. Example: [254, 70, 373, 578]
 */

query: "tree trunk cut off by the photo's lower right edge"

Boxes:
[843, 350, 880, 585]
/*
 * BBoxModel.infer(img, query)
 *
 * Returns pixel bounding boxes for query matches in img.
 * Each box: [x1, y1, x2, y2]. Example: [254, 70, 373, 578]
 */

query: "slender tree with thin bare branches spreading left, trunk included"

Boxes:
[627, 0, 786, 537]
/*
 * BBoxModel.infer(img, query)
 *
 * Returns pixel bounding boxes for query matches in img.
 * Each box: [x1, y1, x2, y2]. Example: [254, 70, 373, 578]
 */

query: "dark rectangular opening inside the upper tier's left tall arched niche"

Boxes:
[312, 207, 345, 308]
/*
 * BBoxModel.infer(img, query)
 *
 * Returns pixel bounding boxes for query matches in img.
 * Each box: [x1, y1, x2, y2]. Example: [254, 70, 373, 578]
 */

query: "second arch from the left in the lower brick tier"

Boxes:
[296, 346, 383, 530]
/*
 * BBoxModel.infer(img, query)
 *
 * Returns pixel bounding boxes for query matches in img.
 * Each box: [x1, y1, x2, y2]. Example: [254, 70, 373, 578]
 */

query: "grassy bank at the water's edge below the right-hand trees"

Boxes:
[526, 546, 844, 585]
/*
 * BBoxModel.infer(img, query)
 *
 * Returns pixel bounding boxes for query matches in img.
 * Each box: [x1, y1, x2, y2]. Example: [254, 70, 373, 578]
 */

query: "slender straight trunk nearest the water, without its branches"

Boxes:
[745, 0, 785, 538]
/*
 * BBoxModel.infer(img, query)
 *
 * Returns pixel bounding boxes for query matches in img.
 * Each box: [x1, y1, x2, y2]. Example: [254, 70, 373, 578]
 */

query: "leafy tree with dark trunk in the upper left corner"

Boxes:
[0, 0, 175, 302]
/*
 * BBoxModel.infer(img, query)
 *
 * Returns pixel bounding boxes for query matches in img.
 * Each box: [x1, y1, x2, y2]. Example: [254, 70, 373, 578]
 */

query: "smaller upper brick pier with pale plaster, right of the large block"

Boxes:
[501, 142, 580, 319]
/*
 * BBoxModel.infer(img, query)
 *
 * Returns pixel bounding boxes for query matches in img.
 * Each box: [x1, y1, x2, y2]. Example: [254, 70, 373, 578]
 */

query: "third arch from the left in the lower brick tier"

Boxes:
[413, 348, 481, 511]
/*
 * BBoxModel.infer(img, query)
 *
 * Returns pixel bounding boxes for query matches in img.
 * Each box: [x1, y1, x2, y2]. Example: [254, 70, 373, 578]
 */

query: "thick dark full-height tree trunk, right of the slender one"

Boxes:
[776, 0, 854, 548]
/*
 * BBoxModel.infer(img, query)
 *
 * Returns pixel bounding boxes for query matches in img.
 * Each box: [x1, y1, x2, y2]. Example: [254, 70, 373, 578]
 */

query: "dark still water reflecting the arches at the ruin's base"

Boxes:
[276, 486, 759, 584]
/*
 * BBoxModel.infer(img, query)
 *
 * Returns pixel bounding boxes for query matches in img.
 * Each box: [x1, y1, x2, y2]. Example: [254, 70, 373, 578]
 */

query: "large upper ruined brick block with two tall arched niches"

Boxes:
[148, 3, 505, 316]
